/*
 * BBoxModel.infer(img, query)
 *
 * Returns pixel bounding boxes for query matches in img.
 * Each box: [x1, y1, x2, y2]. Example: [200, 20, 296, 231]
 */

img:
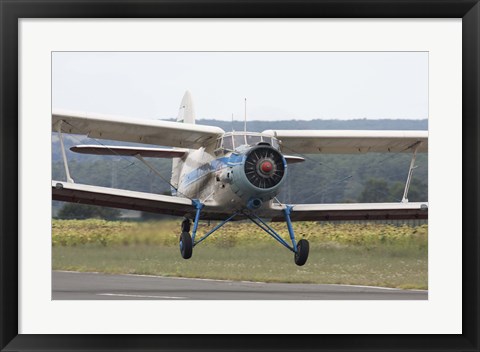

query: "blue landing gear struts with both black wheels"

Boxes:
[180, 199, 309, 266]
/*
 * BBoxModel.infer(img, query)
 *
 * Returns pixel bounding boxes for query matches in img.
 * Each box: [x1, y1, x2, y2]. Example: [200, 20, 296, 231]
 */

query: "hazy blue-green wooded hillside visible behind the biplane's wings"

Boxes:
[52, 119, 428, 203]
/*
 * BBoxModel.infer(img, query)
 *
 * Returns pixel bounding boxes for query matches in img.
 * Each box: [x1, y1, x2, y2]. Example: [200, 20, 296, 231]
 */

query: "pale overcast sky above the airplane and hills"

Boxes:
[52, 52, 428, 120]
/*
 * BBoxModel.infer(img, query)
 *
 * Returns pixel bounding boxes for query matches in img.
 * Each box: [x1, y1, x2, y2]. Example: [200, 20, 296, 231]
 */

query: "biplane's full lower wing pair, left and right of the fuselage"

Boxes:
[52, 181, 428, 221]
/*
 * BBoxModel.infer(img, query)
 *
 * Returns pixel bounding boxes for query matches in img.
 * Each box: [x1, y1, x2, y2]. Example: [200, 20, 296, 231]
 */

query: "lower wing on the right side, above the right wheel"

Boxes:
[270, 202, 428, 221]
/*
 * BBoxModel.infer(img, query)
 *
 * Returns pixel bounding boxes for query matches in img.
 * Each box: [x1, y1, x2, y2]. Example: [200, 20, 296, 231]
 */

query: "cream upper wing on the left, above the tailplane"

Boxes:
[52, 111, 224, 149]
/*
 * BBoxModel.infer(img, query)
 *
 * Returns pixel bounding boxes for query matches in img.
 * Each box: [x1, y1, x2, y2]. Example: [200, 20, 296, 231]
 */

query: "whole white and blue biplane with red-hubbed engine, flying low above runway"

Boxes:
[52, 91, 428, 265]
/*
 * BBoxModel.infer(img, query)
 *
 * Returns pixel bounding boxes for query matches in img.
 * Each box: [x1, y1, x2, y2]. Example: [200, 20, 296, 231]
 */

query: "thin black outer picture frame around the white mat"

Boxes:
[0, 0, 480, 351]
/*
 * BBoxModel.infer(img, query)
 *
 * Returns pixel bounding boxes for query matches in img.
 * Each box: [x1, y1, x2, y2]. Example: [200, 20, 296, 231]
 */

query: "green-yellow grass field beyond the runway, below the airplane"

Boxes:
[52, 220, 428, 289]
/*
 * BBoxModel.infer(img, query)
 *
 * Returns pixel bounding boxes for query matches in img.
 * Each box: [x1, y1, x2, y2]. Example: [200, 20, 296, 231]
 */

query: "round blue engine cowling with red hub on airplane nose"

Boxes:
[231, 145, 287, 208]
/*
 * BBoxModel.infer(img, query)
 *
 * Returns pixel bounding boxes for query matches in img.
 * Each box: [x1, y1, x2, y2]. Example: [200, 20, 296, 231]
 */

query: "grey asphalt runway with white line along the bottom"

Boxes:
[52, 271, 428, 300]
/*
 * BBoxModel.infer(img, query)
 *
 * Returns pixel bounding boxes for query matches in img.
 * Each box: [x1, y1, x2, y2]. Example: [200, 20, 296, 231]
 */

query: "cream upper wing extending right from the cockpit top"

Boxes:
[263, 130, 428, 154]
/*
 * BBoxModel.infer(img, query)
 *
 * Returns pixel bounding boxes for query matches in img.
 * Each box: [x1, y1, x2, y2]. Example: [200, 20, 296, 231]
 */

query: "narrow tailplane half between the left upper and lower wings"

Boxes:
[70, 145, 188, 158]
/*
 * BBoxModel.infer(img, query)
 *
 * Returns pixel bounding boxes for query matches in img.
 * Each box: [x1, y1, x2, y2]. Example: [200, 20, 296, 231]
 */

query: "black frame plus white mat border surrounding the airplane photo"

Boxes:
[0, 0, 480, 351]
